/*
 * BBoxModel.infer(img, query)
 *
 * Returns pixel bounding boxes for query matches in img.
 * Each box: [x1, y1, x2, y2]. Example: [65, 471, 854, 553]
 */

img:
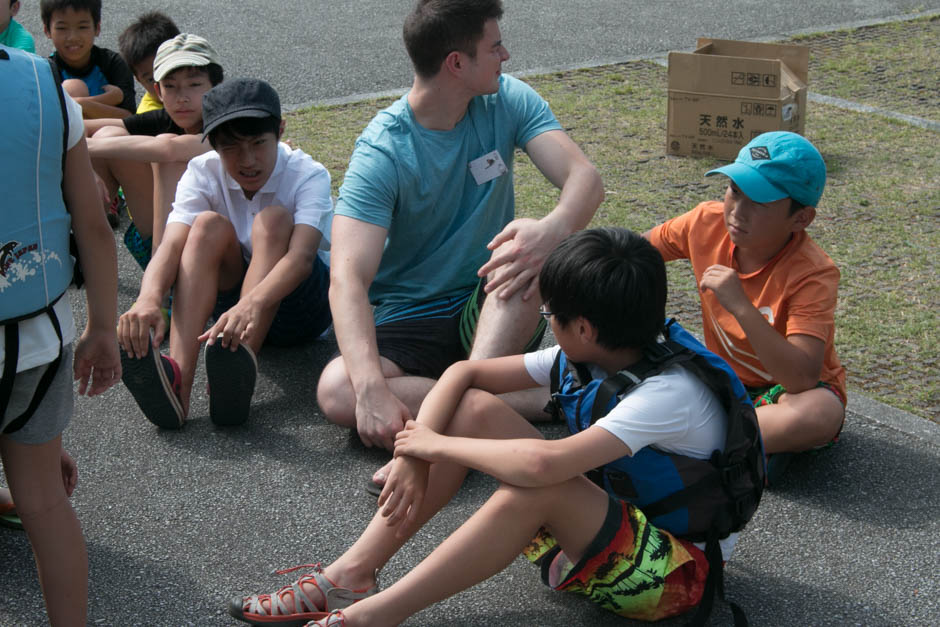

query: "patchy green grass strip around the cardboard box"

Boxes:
[288, 20, 940, 420]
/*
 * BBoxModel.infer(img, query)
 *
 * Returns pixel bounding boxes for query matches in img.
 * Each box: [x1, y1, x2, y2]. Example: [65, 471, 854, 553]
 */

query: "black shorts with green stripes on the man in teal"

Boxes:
[375, 280, 546, 379]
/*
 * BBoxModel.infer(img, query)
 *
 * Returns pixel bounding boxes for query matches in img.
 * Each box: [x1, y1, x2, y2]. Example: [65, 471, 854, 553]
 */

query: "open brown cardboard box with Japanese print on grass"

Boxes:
[666, 38, 809, 160]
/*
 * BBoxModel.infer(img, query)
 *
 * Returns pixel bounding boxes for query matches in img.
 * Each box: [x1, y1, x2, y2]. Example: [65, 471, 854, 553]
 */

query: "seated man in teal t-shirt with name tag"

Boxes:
[317, 0, 604, 462]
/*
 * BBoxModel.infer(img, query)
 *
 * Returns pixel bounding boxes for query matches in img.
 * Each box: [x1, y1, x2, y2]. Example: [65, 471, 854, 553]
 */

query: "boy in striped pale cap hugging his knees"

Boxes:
[85, 33, 223, 255]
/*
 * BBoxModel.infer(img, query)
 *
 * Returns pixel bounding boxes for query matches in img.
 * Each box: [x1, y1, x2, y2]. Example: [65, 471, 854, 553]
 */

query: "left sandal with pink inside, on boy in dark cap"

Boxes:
[120, 331, 186, 429]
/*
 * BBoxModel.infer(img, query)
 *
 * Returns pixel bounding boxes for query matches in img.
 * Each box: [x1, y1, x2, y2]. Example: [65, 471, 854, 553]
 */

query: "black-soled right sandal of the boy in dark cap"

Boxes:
[206, 336, 258, 426]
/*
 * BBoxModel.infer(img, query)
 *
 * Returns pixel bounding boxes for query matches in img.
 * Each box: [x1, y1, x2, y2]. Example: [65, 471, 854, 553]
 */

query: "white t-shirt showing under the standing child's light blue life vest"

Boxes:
[0, 94, 85, 372]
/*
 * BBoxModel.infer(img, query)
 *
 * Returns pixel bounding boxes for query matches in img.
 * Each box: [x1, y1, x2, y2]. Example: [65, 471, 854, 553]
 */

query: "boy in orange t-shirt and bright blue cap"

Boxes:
[646, 132, 846, 483]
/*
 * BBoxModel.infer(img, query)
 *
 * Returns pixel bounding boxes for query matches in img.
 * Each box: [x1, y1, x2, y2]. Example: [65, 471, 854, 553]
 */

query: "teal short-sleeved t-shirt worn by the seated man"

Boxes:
[336, 75, 561, 324]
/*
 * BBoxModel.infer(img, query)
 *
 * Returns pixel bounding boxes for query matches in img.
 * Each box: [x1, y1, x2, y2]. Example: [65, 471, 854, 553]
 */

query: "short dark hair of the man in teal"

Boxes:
[402, 0, 503, 78]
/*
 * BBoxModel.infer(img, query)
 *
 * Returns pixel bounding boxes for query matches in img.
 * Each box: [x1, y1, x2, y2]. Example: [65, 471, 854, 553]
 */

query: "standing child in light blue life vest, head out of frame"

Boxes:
[0, 46, 121, 625]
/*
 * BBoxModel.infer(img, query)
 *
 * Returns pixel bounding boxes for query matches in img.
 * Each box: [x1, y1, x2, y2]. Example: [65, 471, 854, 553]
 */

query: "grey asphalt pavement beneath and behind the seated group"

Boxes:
[0, 0, 940, 626]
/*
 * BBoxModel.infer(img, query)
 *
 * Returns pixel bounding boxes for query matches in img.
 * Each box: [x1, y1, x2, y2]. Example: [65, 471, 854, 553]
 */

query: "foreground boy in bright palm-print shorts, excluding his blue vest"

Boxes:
[230, 228, 762, 627]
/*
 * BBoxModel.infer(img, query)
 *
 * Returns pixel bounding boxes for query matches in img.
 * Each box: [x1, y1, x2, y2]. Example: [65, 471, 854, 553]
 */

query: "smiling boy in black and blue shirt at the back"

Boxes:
[39, 0, 136, 118]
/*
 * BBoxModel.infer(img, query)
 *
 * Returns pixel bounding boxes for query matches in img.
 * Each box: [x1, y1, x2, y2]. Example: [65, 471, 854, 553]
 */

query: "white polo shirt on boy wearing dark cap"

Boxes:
[167, 143, 333, 261]
